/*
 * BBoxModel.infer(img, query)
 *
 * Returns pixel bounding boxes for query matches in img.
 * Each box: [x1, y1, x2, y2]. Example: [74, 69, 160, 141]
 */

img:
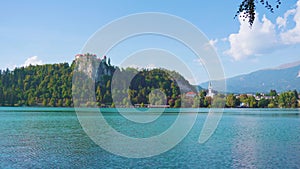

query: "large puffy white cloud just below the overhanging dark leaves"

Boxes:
[225, 14, 278, 60]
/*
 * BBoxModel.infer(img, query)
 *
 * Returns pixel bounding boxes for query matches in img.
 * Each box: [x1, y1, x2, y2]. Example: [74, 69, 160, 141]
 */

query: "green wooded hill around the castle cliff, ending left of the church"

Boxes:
[0, 62, 195, 107]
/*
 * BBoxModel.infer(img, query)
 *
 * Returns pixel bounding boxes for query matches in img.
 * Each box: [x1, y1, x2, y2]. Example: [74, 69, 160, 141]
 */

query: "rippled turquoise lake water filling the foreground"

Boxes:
[0, 107, 300, 168]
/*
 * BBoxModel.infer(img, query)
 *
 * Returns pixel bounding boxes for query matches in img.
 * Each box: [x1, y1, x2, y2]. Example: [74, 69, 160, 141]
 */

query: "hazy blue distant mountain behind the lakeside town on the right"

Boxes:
[200, 61, 300, 93]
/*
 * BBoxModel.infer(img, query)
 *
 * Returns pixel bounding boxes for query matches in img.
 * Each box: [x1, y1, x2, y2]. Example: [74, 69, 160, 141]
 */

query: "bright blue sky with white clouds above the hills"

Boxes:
[0, 0, 300, 83]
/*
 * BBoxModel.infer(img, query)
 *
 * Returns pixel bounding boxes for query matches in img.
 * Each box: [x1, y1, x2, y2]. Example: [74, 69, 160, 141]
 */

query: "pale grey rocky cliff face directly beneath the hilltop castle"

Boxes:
[75, 53, 113, 82]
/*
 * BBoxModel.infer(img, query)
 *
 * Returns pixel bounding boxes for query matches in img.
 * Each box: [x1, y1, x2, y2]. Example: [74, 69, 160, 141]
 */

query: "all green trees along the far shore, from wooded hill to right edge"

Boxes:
[0, 56, 299, 108]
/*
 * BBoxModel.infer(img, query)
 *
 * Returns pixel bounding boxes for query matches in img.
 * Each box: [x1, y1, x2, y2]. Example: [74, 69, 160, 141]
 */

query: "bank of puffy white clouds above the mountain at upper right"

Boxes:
[224, 0, 300, 60]
